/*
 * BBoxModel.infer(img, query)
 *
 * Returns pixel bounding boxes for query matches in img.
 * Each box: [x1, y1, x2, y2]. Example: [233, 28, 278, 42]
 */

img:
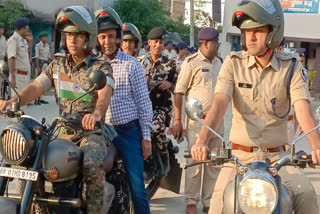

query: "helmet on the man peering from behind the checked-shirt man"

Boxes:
[122, 22, 142, 55]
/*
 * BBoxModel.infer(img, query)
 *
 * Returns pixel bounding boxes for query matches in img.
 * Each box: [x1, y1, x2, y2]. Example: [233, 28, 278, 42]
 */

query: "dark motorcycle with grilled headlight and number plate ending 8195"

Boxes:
[0, 70, 131, 214]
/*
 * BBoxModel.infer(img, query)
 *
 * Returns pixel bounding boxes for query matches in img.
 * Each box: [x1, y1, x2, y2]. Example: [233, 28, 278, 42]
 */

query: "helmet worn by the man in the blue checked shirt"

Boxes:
[94, 7, 123, 48]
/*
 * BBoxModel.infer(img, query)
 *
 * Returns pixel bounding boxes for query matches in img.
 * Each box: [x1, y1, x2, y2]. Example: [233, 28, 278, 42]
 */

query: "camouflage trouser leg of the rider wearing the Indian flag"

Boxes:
[80, 134, 107, 214]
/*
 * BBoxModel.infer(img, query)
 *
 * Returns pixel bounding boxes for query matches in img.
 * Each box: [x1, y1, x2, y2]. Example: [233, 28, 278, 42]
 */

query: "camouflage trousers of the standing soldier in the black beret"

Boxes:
[151, 105, 172, 143]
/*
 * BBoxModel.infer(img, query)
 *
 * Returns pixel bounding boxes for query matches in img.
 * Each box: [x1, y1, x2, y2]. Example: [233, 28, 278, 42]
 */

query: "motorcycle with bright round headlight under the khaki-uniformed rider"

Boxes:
[184, 99, 320, 214]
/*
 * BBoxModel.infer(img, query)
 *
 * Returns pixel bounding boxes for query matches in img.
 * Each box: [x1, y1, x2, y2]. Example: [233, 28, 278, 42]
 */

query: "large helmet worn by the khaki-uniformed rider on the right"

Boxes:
[232, 0, 284, 50]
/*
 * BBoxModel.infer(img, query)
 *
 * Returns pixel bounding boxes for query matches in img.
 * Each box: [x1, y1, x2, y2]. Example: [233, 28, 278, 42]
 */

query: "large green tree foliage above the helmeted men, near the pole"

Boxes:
[115, 0, 199, 35]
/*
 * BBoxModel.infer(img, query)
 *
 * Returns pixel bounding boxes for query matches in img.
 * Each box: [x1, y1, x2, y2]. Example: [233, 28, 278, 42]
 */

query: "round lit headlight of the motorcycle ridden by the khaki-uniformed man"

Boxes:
[238, 172, 278, 214]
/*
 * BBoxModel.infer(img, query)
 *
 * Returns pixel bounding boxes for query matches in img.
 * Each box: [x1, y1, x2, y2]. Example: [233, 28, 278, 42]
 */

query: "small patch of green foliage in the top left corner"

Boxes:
[0, 1, 24, 31]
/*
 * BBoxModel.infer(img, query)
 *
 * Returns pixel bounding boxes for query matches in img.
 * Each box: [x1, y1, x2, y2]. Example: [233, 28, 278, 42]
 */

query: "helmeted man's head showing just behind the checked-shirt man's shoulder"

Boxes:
[121, 22, 142, 57]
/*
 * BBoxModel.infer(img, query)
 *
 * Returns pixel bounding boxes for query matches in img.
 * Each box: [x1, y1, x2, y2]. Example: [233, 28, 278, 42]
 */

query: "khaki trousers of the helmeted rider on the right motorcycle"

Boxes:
[209, 150, 318, 214]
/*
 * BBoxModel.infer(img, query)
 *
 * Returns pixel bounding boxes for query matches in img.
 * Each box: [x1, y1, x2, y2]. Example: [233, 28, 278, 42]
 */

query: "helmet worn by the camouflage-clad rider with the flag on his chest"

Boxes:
[56, 5, 98, 52]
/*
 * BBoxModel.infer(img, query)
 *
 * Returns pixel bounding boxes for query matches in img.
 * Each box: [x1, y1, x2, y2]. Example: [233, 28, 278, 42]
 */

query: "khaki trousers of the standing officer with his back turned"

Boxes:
[184, 119, 221, 207]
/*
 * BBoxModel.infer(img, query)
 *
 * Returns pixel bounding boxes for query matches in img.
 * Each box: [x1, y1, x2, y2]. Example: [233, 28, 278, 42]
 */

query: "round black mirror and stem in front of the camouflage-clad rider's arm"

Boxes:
[69, 70, 107, 114]
